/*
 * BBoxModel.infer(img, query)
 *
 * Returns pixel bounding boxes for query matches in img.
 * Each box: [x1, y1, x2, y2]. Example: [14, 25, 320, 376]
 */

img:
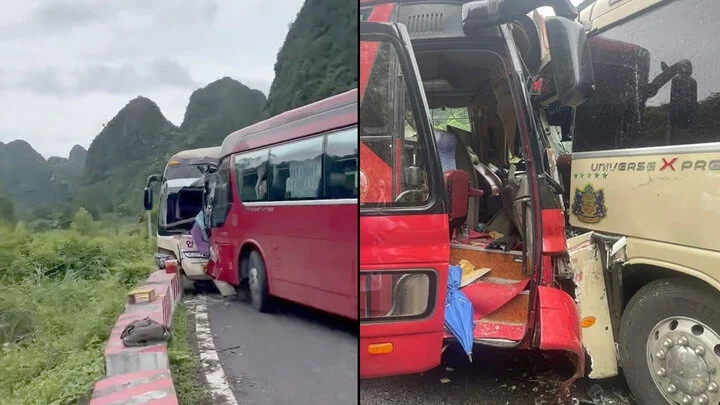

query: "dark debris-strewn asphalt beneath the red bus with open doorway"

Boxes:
[360, 348, 636, 405]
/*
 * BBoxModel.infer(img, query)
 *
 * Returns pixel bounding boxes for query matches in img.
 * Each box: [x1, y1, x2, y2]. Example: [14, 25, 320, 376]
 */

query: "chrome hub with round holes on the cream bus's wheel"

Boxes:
[646, 317, 720, 405]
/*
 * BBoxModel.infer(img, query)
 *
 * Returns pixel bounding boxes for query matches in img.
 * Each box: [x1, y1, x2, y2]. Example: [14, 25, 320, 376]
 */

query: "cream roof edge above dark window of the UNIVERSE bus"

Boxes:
[579, 0, 667, 33]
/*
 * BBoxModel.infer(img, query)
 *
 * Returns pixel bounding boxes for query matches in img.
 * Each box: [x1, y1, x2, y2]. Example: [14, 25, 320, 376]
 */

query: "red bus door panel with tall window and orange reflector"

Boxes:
[359, 22, 449, 378]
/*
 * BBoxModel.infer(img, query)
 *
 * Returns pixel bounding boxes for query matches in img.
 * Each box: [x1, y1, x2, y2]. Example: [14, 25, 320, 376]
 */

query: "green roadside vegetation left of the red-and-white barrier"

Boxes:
[0, 208, 153, 405]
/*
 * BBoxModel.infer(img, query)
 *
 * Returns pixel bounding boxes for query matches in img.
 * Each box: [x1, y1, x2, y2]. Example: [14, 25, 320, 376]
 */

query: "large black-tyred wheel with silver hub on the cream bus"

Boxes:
[619, 279, 720, 405]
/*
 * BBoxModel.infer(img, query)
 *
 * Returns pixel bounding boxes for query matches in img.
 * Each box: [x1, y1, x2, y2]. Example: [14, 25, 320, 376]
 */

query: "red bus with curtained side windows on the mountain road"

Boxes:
[207, 90, 358, 319]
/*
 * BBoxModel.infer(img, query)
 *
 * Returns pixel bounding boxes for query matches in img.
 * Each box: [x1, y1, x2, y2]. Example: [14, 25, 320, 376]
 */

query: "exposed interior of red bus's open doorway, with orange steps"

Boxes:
[413, 18, 540, 345]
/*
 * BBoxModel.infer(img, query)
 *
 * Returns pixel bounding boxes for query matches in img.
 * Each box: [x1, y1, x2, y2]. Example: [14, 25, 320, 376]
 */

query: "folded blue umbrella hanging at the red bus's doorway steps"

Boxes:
[445, 266, 475, 362]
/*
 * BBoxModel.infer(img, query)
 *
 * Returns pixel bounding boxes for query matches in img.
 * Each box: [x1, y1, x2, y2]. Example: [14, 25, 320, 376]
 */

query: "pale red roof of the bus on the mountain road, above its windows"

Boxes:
[220, 89, 358, 157]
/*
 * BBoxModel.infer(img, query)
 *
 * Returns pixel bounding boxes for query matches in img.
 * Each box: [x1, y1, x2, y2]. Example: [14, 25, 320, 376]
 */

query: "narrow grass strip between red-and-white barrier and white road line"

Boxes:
[168, 302, 212, 405]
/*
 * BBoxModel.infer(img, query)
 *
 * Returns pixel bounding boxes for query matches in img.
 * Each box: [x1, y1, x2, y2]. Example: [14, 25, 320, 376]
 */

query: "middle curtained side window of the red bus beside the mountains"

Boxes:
[268, 136, 323, 201]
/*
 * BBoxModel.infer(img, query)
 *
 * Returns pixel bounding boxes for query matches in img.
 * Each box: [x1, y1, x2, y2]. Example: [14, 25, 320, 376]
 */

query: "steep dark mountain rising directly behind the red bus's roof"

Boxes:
[266, 0, 359, 116]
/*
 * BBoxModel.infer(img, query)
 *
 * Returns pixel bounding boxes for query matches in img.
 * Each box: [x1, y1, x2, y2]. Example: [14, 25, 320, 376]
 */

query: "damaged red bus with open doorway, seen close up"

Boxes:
[359, 0, 593, 378]
